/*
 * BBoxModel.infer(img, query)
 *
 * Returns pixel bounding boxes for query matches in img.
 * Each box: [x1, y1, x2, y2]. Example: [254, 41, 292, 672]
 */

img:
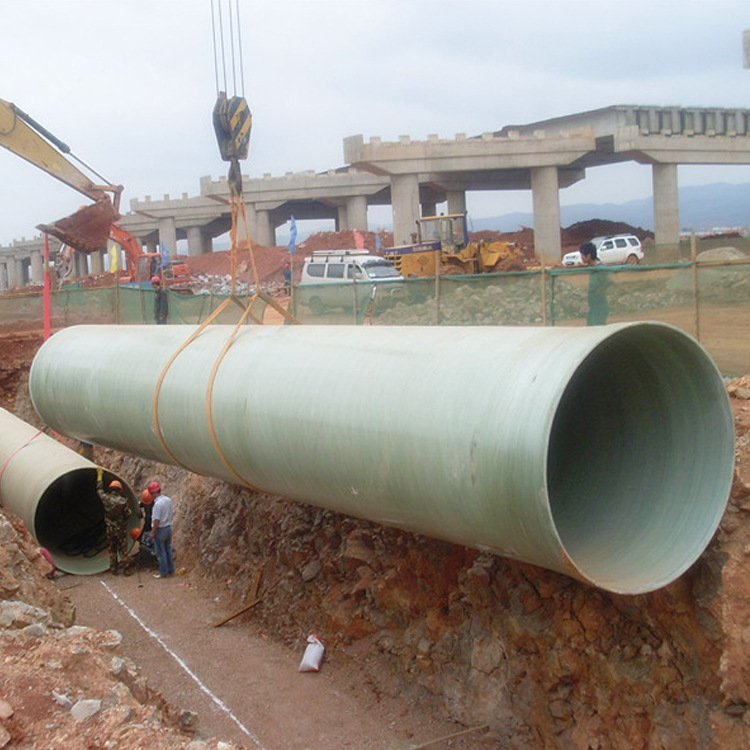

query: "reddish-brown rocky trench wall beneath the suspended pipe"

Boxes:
[91, 440, 750, 750]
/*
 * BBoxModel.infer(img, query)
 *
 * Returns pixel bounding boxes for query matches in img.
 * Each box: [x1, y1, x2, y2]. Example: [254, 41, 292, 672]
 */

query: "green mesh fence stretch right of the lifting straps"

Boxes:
[291, 260, 750, 375]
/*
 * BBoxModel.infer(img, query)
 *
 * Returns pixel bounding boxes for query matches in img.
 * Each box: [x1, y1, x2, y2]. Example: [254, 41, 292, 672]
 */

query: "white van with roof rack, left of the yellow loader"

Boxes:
[299, 250, 406, 313]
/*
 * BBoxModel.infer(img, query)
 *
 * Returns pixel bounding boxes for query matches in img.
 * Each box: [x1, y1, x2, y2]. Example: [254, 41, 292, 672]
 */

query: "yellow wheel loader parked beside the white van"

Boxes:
[383, 211, 525, 277]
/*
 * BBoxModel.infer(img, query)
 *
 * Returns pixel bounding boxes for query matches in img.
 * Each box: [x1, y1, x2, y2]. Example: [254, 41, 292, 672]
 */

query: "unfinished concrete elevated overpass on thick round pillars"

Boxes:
[0, 105, 750, 289]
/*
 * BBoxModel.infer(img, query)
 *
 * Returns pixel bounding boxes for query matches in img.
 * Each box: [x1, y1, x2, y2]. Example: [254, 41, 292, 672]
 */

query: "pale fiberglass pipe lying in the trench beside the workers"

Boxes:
[0, 409, 138, 575]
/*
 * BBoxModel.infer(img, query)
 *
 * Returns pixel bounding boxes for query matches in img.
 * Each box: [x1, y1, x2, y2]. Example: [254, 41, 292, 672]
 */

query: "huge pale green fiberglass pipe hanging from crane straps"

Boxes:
[30, 323, 734, 593]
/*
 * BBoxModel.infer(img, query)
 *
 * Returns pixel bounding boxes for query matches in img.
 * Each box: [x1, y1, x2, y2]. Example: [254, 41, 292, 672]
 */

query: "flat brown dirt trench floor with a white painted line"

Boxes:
[66, 571, 493, 750]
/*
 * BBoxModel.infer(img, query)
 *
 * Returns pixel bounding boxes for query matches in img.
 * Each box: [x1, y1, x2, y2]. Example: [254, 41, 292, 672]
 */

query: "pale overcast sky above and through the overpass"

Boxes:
[0, 0, 750, 245]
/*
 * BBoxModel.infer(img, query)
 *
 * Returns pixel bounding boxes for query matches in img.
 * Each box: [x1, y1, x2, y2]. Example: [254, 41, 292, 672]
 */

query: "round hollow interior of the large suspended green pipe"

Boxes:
[547, 326, 734, 594]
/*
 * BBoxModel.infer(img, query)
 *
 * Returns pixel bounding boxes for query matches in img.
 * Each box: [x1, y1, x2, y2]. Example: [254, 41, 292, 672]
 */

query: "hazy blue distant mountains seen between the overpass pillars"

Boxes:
[471, 183, 750, 232]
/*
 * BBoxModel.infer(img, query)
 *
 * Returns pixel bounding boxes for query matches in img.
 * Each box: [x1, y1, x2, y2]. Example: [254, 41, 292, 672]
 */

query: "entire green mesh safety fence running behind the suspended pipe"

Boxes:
[0, 259, 750, 375]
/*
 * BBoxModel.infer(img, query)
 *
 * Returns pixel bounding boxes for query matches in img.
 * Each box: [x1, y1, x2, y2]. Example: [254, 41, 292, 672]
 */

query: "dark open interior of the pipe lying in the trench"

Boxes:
[34, 468, 138, 575]
